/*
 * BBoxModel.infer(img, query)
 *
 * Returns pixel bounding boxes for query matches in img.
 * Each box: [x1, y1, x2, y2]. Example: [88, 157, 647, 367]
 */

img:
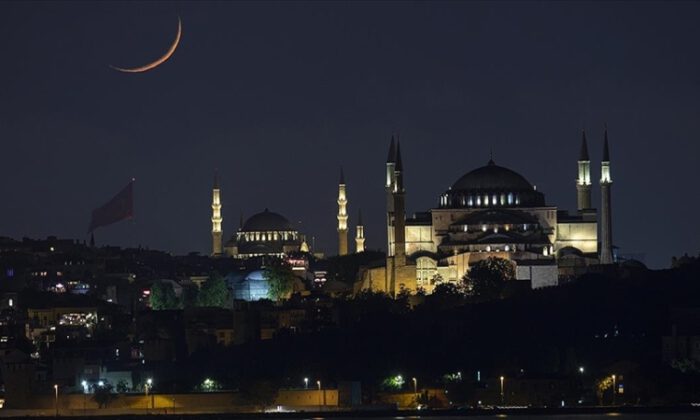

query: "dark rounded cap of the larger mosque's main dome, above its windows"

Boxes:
[452, 160, 534, 192]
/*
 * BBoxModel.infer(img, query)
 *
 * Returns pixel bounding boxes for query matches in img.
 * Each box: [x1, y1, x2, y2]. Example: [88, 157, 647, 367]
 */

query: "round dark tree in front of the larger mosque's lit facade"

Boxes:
[462, 257, 515, 299]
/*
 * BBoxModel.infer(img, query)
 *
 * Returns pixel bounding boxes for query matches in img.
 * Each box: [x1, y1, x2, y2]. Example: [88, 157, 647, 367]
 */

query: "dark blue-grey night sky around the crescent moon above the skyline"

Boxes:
[0, 2, 700, 267]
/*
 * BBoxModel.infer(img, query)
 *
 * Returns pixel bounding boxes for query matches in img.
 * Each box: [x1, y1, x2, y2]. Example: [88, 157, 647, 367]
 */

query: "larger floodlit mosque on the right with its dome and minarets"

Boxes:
[357, 128, 614, 295]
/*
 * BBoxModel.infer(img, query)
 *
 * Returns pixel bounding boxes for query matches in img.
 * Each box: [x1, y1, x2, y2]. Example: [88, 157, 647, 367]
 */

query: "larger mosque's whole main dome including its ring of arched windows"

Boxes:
[440, 160, 544, 208]
